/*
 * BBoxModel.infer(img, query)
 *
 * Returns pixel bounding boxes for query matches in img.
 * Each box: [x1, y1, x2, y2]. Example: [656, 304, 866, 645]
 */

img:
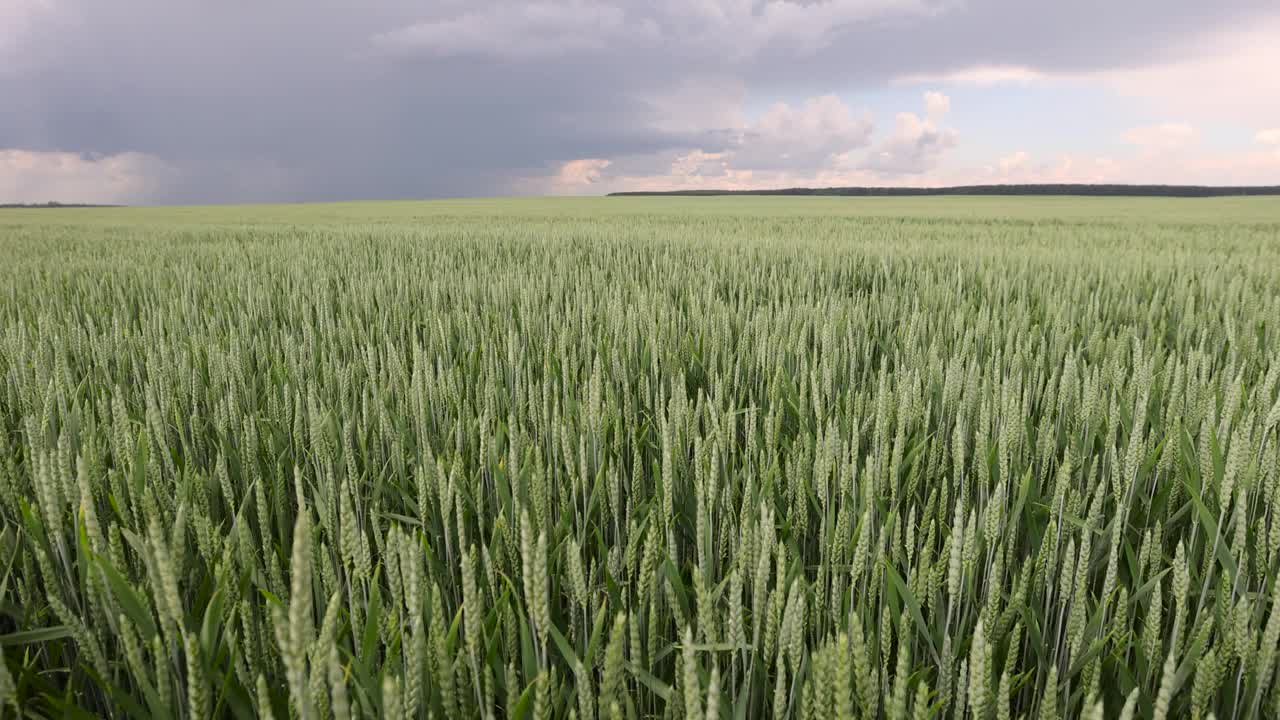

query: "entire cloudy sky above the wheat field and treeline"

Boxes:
[0, 0, 1280, 204]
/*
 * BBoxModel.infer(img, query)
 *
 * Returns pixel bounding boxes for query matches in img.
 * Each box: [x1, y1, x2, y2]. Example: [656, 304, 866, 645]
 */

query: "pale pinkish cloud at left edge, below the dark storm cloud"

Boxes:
[0, 149, 175, 204]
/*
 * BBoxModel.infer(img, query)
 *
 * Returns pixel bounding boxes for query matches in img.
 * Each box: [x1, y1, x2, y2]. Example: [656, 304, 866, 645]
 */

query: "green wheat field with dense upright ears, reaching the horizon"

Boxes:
[0, 197, 1280, 720]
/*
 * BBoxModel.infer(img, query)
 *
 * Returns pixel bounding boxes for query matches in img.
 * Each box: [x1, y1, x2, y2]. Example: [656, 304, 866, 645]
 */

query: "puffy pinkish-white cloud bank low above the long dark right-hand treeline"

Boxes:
[521, 74, 1280, 193]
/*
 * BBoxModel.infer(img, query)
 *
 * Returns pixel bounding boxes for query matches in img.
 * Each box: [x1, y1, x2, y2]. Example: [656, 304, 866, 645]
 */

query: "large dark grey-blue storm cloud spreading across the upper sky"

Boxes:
[0, 0, 1272, 201]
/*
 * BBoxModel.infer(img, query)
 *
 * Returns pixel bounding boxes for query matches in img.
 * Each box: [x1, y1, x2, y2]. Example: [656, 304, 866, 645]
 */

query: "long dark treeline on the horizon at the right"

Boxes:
[609, 184, 1280, 197]
